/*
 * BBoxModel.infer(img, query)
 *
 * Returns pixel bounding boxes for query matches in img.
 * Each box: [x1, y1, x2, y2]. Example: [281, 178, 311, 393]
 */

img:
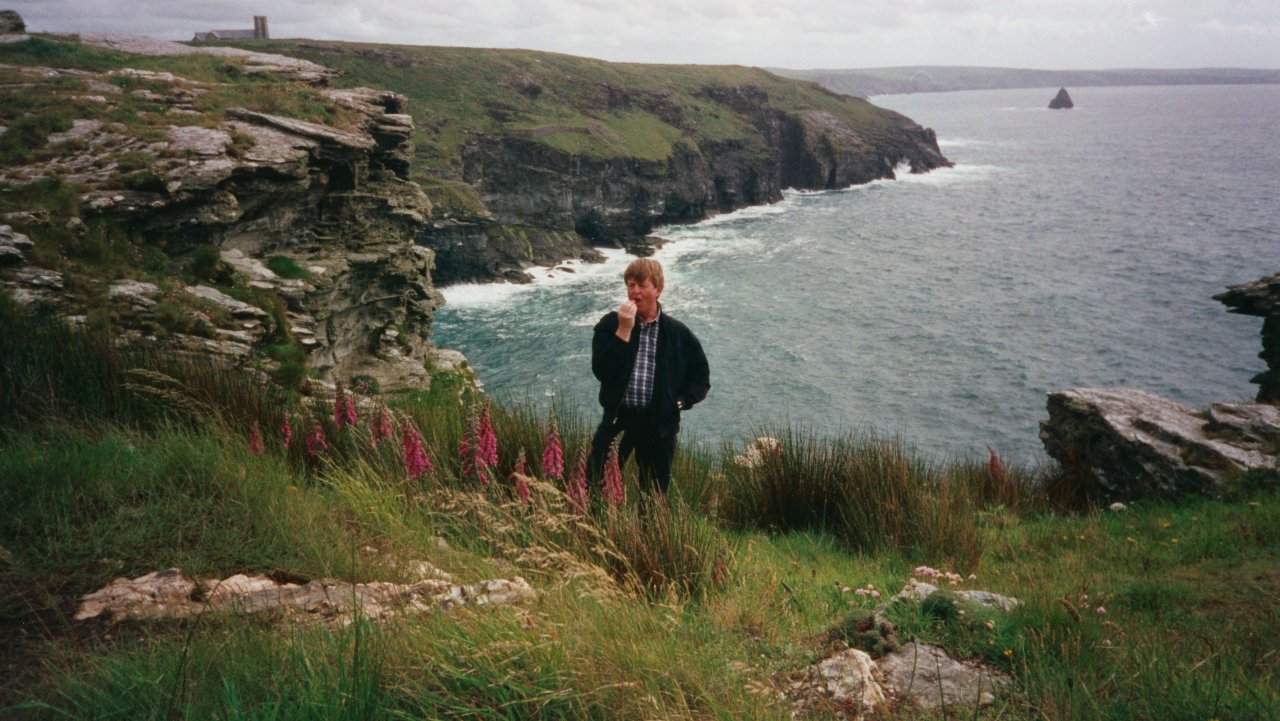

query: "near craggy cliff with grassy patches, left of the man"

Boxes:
[0, 41, 443, 385]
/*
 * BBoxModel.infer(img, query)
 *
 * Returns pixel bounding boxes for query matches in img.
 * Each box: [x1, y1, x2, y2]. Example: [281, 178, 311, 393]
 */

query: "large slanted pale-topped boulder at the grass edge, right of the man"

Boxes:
[1041, 388, 1280, 499]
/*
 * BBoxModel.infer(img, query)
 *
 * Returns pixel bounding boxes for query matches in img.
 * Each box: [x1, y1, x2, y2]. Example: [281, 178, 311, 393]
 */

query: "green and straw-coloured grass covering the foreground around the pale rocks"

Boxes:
[0, 304, 1280, 720]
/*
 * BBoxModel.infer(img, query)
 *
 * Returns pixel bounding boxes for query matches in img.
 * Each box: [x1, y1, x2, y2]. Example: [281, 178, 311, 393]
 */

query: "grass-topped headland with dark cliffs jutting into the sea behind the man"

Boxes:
[225, 41, 948, 284]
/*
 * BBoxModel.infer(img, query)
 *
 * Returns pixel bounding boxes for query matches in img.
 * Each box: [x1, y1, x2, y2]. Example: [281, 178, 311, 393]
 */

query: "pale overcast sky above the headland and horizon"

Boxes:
[10, 0, 1280, 69]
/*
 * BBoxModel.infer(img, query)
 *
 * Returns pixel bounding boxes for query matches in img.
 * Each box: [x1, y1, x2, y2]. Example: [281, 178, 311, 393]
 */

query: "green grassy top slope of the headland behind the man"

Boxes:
[212, 40, 911, 175]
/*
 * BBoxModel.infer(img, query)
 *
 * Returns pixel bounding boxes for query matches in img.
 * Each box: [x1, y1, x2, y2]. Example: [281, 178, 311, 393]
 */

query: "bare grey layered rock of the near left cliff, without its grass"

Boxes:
[0, 52, 443, 387]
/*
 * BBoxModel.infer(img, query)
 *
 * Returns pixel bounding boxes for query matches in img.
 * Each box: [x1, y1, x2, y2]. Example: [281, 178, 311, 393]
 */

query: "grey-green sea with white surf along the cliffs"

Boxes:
[434, 86, 1280, 465]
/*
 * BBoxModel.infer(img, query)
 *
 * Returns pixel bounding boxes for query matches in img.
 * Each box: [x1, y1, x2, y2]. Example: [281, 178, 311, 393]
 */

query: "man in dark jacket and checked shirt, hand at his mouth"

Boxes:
[590, 257, 712, 493]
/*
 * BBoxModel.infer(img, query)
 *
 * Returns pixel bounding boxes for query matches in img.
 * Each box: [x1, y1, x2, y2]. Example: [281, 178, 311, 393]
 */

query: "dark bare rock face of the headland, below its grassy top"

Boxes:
[419, 87, 950, 283]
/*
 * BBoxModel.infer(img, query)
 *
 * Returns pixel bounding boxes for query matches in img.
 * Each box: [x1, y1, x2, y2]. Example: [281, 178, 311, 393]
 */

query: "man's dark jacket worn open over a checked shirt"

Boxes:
[591, 311, 712, 435]
